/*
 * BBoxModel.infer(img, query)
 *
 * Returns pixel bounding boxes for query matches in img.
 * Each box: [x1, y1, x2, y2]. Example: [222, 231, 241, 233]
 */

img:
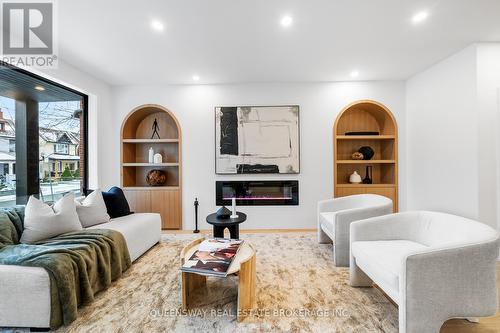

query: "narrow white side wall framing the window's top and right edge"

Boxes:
[34, 60, 112, 188]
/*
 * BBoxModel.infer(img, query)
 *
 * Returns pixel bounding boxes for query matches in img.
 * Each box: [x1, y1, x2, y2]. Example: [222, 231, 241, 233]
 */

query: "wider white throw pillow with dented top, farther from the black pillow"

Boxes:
[21, 192, 82, 243]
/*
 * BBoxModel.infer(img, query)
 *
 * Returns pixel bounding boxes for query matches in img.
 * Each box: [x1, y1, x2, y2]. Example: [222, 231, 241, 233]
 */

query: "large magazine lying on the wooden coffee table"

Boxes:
[181, 238, 243, 276]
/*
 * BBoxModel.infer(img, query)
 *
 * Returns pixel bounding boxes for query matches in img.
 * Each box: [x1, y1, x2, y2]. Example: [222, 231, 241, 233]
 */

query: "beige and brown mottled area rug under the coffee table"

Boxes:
[55, 233, 397, 332]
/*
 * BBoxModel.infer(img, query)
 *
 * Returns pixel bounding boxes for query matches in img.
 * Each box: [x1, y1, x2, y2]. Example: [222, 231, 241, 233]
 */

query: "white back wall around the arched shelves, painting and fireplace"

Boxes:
[109, 82, 406, 229]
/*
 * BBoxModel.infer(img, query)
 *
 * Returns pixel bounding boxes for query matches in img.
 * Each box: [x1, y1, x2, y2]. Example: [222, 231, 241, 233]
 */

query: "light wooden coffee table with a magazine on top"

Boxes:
[181, 238, 256, 321]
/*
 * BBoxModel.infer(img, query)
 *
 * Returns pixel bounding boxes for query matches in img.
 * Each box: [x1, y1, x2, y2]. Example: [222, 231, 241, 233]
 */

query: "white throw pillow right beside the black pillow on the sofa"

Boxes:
[75, 189, 110, 228]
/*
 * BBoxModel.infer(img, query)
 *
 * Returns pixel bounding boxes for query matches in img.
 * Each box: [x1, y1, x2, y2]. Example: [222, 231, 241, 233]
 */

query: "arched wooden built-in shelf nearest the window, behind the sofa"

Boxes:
[120, 104, 182, 229]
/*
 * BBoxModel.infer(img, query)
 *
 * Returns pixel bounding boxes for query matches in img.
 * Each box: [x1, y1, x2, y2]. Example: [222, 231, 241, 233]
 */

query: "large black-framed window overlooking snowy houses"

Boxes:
[0, 63, 87, 207]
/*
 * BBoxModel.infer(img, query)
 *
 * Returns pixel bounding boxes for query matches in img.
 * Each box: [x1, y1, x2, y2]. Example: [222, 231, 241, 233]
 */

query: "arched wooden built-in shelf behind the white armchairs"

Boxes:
[333, 100, 398, 212]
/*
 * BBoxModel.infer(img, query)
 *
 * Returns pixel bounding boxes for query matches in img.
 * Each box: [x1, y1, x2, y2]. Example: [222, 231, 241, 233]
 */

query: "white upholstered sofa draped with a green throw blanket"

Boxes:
[0, 213, 161, 328]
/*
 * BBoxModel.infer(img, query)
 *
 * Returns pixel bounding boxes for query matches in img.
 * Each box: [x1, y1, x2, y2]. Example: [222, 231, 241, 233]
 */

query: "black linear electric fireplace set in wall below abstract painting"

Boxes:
[215, 180, 299, 206]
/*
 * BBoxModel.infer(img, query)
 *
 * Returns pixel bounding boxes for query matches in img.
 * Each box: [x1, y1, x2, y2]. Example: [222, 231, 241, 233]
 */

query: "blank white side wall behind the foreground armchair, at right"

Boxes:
[406, 43, 500, 227]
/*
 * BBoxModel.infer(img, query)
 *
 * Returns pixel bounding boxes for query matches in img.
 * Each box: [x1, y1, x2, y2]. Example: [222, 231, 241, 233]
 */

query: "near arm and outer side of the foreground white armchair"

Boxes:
[399, 238, 499, 332]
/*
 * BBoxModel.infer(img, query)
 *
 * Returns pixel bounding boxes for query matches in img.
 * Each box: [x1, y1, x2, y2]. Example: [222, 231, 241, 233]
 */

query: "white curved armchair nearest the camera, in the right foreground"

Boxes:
[350, 211, 499, 333]
